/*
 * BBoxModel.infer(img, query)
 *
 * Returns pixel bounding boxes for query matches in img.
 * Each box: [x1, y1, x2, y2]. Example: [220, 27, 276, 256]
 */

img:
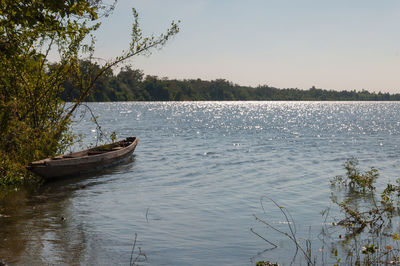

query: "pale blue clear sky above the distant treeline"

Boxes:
[91, 0, 400, 93]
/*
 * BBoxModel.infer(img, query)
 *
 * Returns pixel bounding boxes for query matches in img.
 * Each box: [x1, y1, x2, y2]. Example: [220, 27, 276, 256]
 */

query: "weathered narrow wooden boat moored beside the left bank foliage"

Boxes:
[27, 137, 139, 180]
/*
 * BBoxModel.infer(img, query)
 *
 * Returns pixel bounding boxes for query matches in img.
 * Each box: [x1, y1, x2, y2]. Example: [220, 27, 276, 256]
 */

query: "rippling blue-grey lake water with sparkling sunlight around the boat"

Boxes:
[0, 102, 400, 265]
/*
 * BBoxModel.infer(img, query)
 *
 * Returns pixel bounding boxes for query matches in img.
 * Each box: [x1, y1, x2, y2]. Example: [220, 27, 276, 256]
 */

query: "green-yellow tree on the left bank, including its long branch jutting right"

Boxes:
[0, 0, 179, 187]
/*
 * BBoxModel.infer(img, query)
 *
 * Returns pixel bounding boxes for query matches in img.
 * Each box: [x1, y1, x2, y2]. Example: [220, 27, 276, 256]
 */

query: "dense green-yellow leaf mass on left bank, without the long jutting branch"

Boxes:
[0, 0, 99, 184]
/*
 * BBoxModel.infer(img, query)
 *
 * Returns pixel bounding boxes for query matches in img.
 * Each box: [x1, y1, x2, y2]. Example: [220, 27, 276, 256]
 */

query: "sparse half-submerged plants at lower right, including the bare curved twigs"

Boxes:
[252, 159, 400, 265]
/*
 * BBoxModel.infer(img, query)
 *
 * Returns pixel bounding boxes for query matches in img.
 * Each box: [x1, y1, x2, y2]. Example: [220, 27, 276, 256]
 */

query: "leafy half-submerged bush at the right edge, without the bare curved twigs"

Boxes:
[331, 159, 400, 265]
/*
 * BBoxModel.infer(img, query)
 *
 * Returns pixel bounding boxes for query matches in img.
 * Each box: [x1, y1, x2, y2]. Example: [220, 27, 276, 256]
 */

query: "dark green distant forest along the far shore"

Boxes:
[62, 61, 400, 102]
